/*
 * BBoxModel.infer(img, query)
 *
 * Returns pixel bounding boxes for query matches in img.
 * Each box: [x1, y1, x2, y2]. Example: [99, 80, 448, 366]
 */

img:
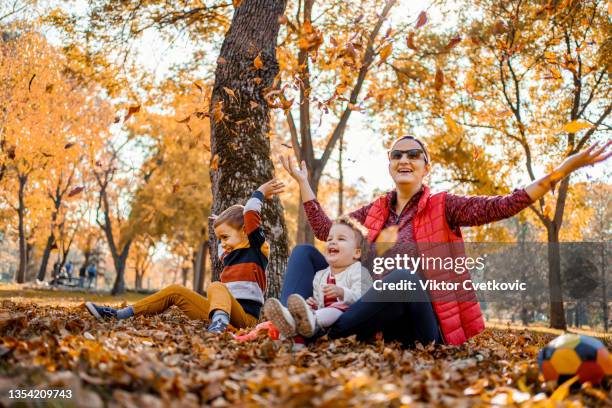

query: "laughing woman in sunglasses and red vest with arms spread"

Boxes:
[281, 136, 612, 346]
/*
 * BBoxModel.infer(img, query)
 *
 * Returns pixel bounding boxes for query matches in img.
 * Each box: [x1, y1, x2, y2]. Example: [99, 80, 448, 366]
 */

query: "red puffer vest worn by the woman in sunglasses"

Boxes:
[364, 186, 484, 345]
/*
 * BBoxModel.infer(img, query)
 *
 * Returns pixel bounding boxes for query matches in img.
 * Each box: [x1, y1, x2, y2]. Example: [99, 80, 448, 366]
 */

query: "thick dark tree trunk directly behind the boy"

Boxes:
[210, 0, 288, 296]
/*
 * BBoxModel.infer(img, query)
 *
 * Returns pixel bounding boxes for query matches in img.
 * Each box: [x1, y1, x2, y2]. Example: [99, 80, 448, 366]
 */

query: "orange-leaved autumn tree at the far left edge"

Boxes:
[0, 25, 104, 282]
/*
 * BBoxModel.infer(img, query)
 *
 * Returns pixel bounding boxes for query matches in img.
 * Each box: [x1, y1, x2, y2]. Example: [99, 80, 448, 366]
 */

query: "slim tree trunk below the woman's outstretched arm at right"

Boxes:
[547, 222, 566, 330]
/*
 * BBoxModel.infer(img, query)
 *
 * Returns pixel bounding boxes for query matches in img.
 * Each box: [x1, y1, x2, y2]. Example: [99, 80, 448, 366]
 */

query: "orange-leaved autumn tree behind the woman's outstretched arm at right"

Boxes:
[390, 0, 612, 328]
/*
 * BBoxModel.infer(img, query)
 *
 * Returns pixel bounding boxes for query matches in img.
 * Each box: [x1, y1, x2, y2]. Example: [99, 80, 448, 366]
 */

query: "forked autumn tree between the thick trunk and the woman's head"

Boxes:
[269, 0, 407, 243]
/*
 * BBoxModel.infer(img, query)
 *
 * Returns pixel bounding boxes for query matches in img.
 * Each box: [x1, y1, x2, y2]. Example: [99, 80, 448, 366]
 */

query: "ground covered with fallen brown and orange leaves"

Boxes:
[0, 300, 612, 408]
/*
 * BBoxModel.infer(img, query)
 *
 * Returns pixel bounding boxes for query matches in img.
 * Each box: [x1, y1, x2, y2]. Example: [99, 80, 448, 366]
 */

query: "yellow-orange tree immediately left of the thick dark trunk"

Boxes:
[130, 82, 211, 292]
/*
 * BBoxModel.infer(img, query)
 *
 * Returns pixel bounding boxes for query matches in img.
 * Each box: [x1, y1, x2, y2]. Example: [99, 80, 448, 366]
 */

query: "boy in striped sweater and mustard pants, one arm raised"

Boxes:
[85, 180, 284, 333]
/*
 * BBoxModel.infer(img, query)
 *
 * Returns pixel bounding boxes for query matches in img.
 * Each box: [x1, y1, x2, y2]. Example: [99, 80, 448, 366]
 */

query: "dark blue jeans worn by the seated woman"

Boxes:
[281, 245, 443, 347]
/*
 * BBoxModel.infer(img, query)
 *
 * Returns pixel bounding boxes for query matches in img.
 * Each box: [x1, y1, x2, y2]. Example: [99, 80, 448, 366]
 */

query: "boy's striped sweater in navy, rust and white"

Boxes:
[221, 190, 270, 317]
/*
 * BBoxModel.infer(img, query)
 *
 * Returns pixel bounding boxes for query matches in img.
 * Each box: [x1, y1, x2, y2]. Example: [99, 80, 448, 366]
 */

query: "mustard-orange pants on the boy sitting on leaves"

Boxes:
[132, 282, 258, 329]
